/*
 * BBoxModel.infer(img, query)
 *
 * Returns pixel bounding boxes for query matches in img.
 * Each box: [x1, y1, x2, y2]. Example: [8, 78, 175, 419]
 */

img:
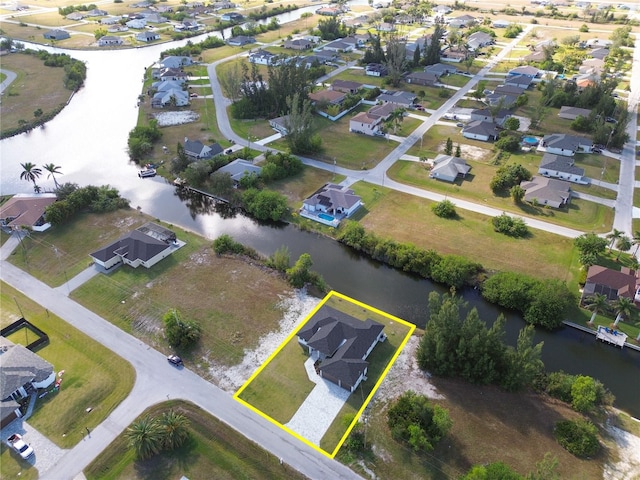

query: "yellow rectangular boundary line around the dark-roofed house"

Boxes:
[233, 291, 416, 458]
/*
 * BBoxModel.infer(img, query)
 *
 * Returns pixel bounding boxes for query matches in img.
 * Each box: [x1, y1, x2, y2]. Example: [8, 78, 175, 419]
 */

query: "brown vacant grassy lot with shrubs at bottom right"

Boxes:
[352, 378, 610, 479]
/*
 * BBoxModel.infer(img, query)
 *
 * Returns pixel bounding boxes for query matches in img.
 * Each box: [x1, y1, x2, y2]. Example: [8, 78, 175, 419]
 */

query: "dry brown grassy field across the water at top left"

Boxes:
[2, 53, 71, 136]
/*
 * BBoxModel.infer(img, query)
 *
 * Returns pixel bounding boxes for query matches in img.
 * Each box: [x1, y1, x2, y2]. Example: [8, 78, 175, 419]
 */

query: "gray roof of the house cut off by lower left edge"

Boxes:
[0, 337, 53, 400]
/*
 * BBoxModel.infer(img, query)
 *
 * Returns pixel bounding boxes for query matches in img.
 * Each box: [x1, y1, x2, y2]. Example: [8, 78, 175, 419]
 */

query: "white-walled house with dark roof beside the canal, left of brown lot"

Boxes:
[89, 222, 184, 270]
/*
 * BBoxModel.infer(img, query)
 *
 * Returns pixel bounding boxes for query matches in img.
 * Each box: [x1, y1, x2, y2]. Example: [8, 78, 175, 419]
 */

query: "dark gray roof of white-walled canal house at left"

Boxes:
[90, 224, 175, 262]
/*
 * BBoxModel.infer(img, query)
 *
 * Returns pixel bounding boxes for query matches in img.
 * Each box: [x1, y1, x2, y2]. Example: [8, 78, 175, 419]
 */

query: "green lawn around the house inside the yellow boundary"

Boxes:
[239, 295, 411, 453]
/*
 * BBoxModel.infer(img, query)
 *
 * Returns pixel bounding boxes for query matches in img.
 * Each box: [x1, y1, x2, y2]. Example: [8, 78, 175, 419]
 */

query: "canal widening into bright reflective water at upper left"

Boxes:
[0, 0, 640, 418]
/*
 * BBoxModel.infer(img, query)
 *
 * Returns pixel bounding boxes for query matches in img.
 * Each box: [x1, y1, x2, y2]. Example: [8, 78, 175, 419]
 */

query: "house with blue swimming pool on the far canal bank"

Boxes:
[300, 183, 362, 227]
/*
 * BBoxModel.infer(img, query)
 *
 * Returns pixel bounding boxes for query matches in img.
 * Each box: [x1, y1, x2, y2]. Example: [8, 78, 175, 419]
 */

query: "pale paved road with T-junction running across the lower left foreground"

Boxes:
[0, 260, 360, 480]
